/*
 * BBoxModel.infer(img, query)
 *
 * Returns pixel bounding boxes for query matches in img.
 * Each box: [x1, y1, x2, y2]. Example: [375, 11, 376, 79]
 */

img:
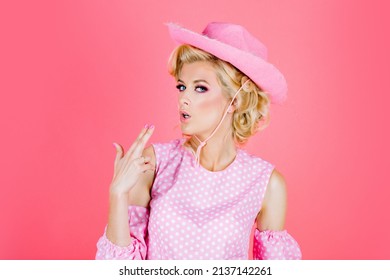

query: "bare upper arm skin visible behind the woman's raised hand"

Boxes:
[128, 145, 156, 207]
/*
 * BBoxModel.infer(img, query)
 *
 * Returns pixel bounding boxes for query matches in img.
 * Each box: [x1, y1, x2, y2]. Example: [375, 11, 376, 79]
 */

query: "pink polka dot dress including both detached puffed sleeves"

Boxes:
[96, 139, 302, 260]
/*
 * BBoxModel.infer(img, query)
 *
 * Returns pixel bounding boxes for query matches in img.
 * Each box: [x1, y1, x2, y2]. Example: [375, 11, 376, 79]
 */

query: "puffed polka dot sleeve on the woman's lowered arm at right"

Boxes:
[253, 228, 302, 260]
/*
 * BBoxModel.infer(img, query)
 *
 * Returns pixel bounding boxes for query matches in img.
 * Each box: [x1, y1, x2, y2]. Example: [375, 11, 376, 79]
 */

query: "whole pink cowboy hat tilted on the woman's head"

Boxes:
[167, 22, 287, 103]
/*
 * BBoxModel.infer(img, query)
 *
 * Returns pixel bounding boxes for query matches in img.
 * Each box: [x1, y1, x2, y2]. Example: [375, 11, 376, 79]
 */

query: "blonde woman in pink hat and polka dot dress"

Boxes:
[96, 23, 301, 259]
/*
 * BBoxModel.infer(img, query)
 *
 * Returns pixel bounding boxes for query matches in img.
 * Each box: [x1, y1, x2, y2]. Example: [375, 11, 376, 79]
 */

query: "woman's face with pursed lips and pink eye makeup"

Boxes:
[176, 61, 229, 139]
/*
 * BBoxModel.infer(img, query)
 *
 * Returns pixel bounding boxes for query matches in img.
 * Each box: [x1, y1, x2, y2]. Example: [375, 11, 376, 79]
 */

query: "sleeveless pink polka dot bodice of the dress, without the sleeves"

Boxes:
[147, 139, 273, 259]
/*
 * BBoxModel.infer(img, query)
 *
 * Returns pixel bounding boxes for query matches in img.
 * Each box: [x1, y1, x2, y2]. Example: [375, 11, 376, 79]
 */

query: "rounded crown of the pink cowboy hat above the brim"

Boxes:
[202, 22, 267, 60]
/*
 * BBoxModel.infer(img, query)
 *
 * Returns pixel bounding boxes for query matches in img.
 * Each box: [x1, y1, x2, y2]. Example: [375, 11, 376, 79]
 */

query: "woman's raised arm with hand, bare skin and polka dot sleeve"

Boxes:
[96, 126, 155, 259]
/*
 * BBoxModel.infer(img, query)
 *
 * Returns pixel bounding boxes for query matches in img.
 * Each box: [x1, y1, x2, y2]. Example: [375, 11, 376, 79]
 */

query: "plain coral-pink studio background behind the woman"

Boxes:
[0, 0, 390, 259]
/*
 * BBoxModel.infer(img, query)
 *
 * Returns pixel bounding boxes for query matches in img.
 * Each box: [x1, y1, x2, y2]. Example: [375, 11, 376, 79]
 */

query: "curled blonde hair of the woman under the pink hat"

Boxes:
[168, 45, 270, 145]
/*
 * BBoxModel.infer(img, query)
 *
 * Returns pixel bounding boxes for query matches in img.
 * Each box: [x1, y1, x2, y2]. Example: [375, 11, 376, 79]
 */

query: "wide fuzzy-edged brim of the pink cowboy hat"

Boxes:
[167, 23, 287, 104]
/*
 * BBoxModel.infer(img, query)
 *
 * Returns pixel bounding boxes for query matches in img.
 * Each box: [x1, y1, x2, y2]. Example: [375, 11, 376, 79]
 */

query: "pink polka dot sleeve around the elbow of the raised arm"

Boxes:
[95, 205, 149, 260]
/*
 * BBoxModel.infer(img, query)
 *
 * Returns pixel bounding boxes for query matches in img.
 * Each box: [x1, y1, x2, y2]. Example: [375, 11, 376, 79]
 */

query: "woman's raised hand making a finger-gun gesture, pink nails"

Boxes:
[110, 125, 155, 194]
